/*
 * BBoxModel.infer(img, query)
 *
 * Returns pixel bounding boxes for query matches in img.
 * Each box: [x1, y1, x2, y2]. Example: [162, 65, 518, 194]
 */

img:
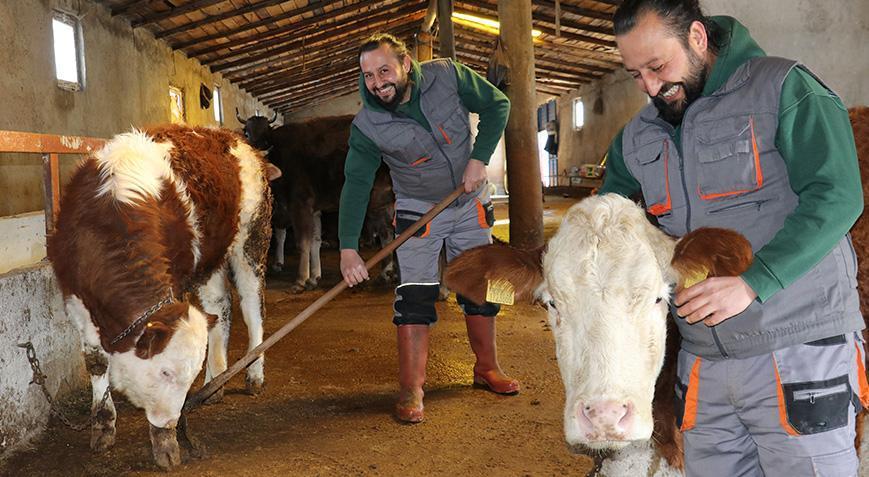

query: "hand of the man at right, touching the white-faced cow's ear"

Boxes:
[675, 277, 757, 326]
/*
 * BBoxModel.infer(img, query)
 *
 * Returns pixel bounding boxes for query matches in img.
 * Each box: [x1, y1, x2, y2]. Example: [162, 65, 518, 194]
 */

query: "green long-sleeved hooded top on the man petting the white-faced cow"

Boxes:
[599, 17, 863, 302]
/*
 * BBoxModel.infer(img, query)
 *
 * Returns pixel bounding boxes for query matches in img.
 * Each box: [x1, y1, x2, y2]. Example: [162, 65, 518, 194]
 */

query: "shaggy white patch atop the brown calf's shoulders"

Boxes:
[94, 130, 174, 204]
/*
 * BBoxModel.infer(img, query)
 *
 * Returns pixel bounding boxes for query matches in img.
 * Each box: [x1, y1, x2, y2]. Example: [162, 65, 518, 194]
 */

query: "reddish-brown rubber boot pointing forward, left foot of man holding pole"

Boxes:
[395, 325, 429, 424]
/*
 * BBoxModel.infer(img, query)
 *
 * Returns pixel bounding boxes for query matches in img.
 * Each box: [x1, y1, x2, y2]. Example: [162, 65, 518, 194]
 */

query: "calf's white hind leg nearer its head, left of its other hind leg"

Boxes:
[199, 268, 232, 404]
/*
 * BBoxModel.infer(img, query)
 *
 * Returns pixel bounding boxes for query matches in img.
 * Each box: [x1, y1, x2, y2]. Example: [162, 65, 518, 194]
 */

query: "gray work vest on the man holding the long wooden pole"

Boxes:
[353, 59, 479, 205]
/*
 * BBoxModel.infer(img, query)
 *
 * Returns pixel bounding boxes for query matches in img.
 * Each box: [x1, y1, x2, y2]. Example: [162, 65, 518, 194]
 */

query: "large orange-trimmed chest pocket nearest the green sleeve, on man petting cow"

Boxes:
[696, 116, 763, 200]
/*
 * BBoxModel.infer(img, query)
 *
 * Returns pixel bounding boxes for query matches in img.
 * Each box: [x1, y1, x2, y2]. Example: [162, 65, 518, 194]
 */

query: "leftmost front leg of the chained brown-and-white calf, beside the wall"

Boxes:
[64, 295, 117, 452]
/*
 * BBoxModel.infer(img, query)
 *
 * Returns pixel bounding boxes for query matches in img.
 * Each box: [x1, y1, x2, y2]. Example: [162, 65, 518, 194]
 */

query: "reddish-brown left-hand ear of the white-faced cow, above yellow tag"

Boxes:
[444, 245, 543, 305]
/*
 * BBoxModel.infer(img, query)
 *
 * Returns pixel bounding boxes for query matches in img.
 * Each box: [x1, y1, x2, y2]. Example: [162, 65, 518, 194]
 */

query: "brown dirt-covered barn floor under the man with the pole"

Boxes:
[0, 194, 592, 477]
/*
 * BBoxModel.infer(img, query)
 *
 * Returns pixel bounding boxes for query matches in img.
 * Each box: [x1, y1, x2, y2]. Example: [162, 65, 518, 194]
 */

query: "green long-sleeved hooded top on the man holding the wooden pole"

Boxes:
[338, 61, 510, 249]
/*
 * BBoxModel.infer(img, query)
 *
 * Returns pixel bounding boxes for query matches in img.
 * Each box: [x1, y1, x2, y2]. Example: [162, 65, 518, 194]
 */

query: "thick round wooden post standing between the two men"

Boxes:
[498, 0, 544, 248]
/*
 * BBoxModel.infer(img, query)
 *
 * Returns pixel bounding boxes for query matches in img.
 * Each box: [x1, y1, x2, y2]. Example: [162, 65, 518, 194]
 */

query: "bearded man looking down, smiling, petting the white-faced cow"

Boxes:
[600, 0, 869, 477]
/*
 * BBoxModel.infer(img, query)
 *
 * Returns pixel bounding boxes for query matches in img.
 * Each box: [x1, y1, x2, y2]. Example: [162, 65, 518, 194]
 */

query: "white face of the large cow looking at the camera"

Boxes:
[539, 194, 674, 448]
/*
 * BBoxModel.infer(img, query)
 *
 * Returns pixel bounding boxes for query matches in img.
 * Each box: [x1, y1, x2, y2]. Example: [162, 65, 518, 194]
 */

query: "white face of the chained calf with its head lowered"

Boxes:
[110, 306, 208, 428]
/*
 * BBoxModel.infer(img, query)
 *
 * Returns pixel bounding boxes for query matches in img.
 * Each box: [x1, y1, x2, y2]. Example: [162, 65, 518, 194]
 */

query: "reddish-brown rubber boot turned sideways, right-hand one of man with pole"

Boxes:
[465, 315, 519, 394]
